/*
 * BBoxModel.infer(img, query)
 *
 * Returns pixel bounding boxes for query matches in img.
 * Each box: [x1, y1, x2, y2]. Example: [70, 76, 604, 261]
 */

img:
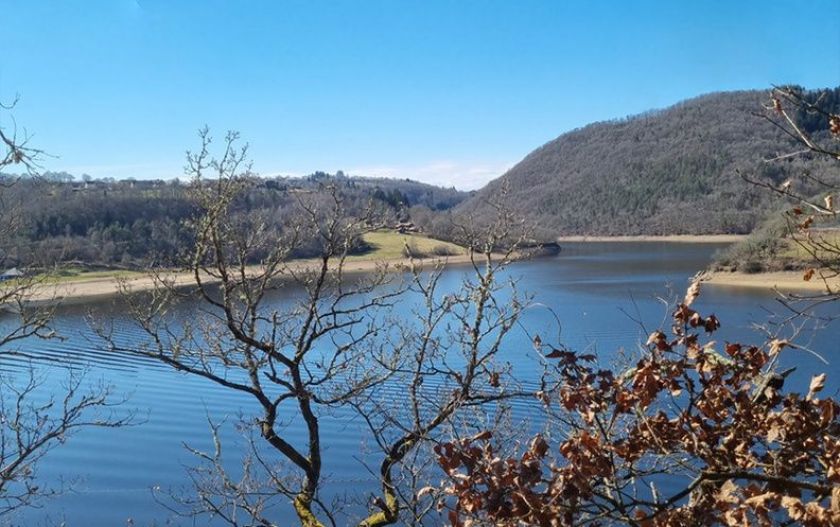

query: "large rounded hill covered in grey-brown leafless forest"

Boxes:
[456, 88, 840, 236]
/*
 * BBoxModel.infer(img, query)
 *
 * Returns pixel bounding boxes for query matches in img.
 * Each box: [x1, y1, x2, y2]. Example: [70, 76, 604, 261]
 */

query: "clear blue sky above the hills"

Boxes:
[0, 0, 840, 189]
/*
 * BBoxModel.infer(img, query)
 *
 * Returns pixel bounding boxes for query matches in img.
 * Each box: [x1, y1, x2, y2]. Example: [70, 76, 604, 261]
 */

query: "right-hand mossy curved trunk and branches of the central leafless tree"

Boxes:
[353, 198, 537, 526]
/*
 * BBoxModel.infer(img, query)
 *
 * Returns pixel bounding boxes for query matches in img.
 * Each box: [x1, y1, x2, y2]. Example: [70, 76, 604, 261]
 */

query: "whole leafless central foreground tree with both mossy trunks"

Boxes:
[104, 129, 540, 527]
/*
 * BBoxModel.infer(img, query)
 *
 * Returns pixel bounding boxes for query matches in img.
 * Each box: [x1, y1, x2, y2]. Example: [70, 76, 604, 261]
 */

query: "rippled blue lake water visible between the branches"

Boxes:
[0, 243, 840, 525]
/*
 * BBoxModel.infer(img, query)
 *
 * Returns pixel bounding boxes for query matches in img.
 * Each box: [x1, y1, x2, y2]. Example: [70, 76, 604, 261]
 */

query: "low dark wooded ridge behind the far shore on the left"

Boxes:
[0, 172, 467, 268]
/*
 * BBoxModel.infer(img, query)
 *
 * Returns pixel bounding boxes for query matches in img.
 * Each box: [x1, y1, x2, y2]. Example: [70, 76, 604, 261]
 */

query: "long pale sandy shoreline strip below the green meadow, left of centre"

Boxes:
[11, 255, 486, 307]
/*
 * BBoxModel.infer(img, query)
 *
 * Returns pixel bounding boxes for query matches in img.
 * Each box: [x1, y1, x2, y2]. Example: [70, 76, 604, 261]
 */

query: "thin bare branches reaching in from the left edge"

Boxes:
[0, 99, 130, 517]
